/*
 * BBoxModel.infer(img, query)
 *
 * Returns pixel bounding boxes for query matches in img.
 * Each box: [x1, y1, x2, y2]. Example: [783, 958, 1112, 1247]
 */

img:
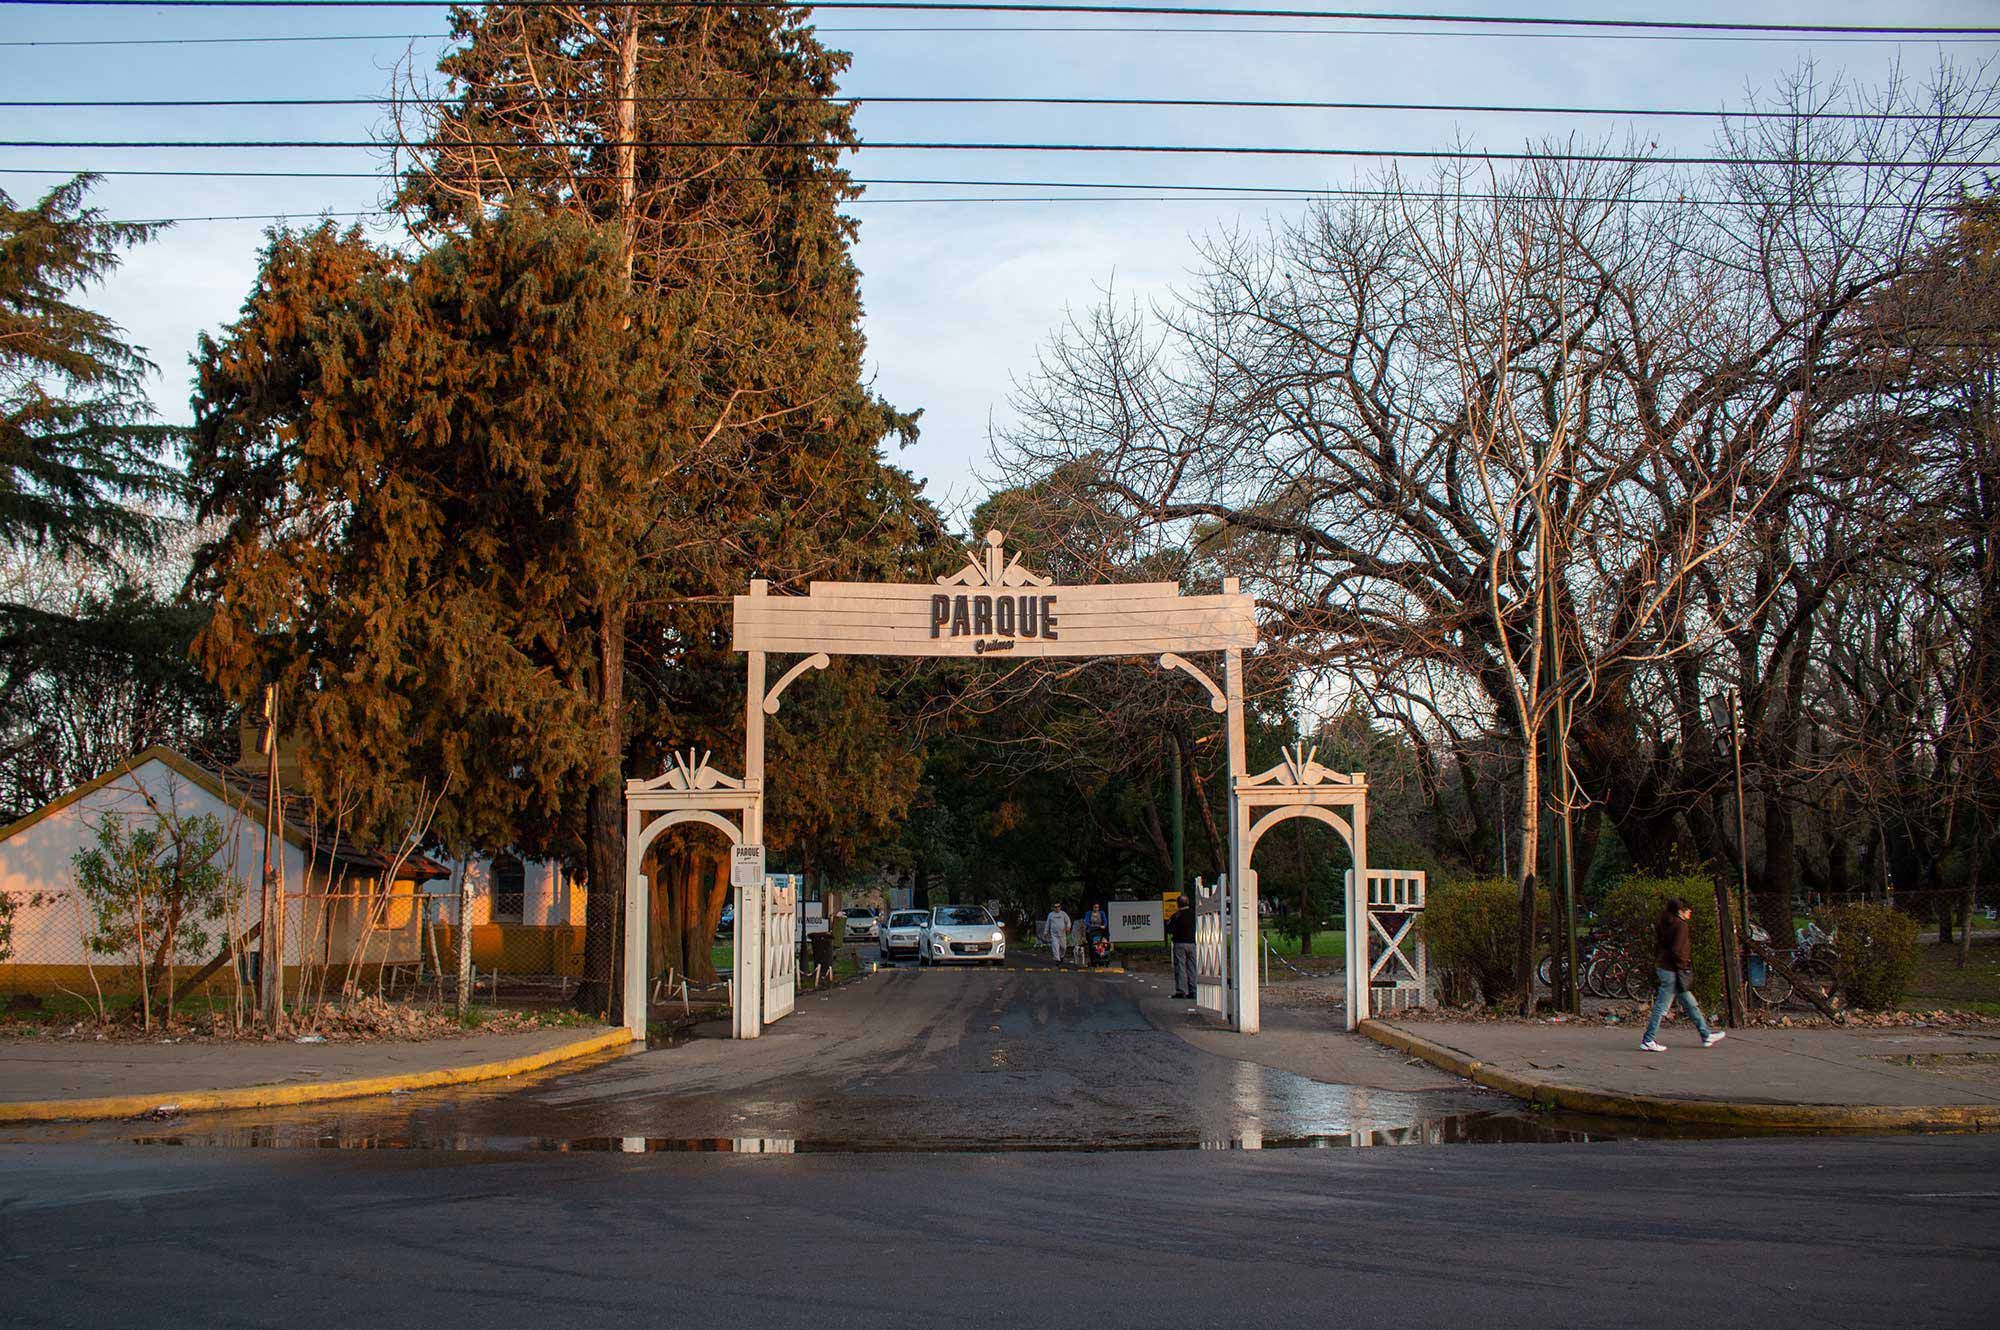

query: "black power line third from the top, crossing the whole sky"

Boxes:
[0, 94, 2000, 124]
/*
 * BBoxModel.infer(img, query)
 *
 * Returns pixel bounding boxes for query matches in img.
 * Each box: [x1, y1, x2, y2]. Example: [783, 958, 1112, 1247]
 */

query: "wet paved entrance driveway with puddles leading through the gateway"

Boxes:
[0, 960, 1520, 1150]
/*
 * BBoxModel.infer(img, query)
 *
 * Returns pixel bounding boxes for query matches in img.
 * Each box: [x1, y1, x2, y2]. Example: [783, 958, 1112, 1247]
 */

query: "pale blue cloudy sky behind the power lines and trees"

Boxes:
[0, 0, 2000, 514]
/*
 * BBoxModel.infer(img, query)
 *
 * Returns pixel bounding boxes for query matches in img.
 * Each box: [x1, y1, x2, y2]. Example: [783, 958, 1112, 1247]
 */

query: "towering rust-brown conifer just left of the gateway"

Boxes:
[196, 6, 940, 1010]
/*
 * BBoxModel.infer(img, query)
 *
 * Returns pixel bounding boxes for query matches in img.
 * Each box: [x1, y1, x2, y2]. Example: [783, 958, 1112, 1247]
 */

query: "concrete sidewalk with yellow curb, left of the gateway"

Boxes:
[0, 1026, 632, 1122]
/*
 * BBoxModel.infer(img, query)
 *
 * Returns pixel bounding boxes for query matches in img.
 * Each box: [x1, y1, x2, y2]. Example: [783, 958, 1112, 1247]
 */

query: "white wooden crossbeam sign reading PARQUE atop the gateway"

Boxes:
[734, 532, 1256, 658]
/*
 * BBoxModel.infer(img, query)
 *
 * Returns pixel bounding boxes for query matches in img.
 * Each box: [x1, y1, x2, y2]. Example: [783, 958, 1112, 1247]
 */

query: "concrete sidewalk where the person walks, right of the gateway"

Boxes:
[1362, 1020, 2000, 1128]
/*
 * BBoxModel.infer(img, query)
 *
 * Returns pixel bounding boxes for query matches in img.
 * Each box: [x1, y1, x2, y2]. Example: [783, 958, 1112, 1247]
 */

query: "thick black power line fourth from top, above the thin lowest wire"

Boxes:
[0, 139, 2000, 168]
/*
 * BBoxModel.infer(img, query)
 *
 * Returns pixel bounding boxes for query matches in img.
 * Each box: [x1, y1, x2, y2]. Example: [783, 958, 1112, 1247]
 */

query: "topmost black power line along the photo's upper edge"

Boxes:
[0, 0, 2000, 36]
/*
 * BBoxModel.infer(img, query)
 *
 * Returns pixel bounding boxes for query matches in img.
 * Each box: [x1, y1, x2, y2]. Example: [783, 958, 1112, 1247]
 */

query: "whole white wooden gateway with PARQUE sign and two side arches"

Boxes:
[624, 532, 1420, 1040]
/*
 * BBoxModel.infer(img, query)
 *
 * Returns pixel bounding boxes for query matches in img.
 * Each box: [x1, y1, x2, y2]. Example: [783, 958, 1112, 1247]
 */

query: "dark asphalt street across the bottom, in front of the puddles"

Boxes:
[0, 1136, 2000, 1330]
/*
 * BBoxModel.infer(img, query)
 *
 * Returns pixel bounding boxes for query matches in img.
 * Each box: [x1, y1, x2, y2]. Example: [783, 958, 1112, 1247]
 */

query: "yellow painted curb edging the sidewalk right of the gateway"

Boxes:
[1358, 1020, 2000, 1132]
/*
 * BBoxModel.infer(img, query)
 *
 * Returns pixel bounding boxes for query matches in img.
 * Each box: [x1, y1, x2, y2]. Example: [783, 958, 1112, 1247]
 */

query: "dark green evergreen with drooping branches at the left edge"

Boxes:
[0, 176, 176, 556]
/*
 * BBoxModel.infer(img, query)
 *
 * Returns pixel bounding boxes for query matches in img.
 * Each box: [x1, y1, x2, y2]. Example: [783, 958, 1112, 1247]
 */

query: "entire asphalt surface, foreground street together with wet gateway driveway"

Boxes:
[0, 968, 2000, 1330]
